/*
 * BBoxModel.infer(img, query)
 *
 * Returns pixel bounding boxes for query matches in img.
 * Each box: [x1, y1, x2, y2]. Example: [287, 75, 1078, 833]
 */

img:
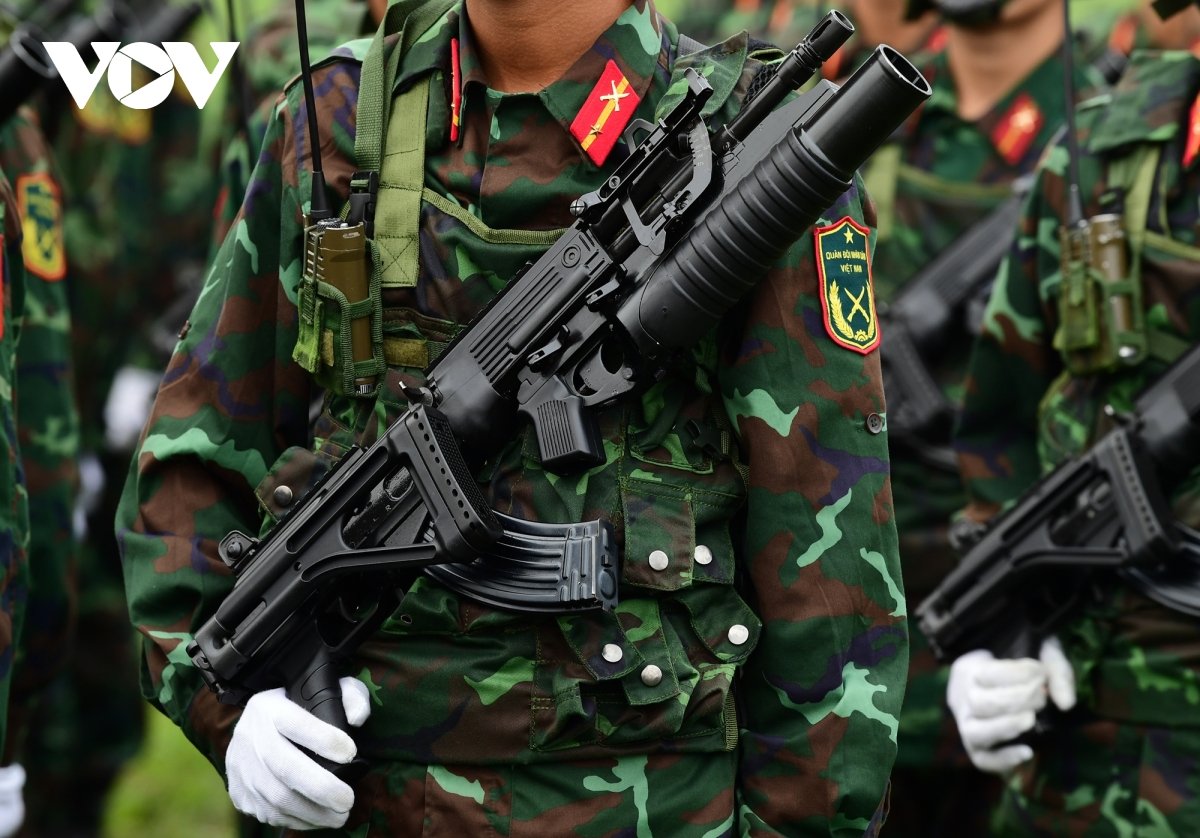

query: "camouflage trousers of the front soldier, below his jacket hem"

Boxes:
[288, 753, 738, 838]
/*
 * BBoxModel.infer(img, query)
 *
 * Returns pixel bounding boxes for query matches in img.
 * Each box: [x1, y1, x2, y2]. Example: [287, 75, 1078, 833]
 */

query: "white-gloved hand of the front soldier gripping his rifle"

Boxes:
[226, 678, 371, 830]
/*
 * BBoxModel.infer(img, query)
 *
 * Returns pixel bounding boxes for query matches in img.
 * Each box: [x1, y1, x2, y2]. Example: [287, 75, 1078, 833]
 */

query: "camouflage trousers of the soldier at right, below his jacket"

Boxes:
[994, 719, 1200, 838]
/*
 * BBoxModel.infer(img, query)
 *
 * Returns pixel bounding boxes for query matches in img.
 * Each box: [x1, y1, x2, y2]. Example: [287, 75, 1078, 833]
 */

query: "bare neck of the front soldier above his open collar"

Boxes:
[467, 0, 632, 92]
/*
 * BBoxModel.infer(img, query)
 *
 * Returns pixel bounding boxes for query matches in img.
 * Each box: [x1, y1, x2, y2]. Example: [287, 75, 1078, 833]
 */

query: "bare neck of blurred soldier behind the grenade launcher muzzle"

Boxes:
[946, 2, 1063, 121]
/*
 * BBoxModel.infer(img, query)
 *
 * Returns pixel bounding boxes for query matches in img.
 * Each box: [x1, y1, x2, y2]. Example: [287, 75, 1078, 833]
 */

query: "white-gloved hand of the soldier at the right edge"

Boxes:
[946, 638, 1075, 774]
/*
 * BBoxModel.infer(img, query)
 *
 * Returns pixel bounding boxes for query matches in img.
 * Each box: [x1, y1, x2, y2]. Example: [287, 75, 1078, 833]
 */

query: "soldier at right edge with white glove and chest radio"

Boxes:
[948, 0, 1200, 836]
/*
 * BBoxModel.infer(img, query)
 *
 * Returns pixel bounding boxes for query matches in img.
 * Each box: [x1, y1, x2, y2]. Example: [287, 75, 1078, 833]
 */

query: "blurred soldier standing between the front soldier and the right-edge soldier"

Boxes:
[849, 0, 1100, 837]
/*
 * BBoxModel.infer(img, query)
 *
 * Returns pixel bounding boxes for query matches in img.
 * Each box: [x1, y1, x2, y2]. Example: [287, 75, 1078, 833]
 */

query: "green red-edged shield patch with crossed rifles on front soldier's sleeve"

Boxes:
[812, 216, 880, 355]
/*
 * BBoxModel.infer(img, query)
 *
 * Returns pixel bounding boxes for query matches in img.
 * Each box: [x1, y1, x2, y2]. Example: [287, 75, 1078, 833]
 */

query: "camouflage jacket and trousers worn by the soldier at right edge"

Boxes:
[958, 53, 1200, 836]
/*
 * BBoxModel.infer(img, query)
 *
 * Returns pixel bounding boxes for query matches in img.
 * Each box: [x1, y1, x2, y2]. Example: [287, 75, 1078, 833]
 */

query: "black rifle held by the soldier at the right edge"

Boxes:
[917, 346, 1200, 660]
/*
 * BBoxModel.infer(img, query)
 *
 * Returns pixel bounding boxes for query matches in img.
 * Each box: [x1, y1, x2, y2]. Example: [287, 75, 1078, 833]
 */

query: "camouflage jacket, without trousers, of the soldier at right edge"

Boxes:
[956, 53, 1200, 728]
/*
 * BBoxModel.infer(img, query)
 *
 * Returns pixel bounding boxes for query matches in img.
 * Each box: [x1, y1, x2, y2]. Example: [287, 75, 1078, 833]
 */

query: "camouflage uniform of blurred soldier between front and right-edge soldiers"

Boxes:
[866, 40, 1090, 749]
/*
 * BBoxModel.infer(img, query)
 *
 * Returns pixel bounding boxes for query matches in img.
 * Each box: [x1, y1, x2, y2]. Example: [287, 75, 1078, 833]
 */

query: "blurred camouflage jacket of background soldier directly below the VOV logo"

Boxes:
[42, 3, 228, 450]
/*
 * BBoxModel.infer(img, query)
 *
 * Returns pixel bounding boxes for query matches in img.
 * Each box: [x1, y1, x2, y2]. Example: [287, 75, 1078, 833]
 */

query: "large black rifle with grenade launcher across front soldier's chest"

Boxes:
[187, 13, 930, 744]
